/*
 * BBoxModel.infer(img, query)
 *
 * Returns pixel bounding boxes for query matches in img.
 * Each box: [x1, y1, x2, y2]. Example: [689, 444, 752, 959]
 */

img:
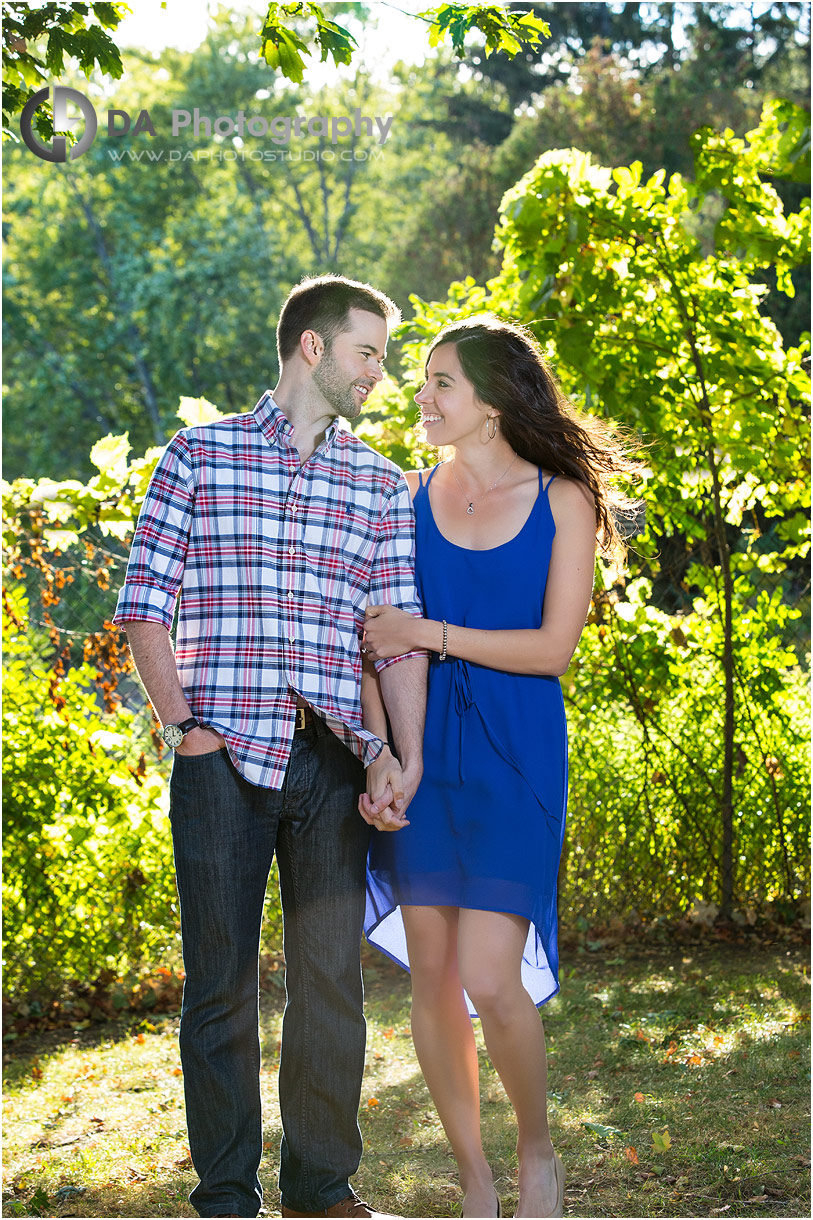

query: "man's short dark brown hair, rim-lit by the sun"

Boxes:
[277, 275, 400, 364]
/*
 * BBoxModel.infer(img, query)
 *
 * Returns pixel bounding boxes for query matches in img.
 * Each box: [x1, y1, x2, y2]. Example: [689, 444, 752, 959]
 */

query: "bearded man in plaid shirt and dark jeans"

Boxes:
[115, 276, 426, 1216]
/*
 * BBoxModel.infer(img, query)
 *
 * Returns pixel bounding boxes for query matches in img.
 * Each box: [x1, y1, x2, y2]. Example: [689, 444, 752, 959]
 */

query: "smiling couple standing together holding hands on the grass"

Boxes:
[115, 276, 636, 1216]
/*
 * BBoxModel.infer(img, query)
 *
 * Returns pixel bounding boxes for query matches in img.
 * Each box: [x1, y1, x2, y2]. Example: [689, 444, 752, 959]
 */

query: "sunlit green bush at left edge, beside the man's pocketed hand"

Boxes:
[2, 590, 177, 997]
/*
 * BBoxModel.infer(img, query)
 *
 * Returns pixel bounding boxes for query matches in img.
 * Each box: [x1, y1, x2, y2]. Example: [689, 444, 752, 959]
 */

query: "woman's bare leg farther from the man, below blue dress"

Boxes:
[458, 910, 557, 1216]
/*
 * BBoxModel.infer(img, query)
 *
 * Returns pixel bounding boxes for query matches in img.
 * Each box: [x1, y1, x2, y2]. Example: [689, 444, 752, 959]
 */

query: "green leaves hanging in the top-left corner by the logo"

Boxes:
[2, 2, 128, 143]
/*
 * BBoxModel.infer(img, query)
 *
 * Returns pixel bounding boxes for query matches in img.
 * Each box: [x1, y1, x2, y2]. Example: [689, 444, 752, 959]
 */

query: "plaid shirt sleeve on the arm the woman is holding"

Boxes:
[370, 476, 426, 673]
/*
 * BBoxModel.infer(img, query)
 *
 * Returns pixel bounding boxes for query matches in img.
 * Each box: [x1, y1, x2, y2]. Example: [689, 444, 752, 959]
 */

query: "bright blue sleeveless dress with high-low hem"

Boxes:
[365, 466, 568, 1016]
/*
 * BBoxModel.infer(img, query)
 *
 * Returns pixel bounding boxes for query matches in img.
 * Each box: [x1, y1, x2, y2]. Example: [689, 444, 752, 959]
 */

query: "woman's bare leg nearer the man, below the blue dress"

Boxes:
[402, 906, 497, 1216]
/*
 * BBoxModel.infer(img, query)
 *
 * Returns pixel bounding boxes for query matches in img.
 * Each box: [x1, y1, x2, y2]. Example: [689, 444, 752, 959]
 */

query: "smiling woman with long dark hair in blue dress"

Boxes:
[360, 317, 636, 1216]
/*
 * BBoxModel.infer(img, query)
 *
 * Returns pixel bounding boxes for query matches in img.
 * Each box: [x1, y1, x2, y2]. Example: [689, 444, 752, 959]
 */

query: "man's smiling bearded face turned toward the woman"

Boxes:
[314, 309, 387, 420]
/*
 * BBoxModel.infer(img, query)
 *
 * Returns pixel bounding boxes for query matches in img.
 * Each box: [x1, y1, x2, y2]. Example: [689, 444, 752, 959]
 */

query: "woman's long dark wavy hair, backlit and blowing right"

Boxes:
[426, 315, 643, 554]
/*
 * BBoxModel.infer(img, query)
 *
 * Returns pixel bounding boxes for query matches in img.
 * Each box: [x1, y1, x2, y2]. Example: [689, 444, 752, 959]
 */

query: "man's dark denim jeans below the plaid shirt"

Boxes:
[170, 720, 370, 1216]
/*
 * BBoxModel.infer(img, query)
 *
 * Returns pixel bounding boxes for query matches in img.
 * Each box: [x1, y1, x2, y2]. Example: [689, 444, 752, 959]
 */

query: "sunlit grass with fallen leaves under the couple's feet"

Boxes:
[4, 943, 811, 1218]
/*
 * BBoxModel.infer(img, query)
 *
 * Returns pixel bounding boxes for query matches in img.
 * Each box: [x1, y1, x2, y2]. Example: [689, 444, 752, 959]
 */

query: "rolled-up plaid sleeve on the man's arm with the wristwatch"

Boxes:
[114, 432, 194, 631]
